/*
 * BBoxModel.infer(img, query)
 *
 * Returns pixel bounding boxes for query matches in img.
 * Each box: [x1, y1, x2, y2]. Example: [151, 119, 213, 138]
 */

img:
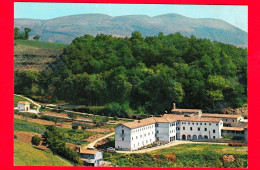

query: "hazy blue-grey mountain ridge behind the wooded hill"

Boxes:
[14, 13, 248, 47]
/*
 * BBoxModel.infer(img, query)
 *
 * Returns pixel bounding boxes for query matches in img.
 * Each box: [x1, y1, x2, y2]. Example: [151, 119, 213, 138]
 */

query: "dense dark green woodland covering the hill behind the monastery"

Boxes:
[15, 32, 247, 116]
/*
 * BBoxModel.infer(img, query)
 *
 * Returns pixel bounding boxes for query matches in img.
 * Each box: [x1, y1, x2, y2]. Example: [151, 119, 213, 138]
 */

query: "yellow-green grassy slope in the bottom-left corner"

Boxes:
[14, 140, 73, 166]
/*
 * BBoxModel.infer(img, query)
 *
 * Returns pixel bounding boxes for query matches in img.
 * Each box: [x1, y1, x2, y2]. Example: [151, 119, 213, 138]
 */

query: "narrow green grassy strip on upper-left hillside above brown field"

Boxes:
[14, 40, 68, 49]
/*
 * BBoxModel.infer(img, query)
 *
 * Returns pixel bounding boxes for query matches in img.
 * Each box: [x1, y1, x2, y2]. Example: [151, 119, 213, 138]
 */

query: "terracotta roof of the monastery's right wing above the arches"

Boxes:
[163, 114, 221, 122]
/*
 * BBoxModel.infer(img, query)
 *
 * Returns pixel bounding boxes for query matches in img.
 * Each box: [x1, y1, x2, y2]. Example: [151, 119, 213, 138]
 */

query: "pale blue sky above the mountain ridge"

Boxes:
[14, 2, 248, 32]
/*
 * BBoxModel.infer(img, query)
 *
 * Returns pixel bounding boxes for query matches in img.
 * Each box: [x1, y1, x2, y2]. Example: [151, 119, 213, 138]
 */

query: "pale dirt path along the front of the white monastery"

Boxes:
[116, 140, 227, 154]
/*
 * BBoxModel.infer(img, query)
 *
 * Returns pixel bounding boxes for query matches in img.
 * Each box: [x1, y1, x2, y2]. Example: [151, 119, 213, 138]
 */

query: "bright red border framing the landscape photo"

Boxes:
[0, 0, 260, 170]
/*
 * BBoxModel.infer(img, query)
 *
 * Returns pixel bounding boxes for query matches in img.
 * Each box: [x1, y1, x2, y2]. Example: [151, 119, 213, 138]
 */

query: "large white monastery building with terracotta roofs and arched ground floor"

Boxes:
[115, 104, 223, 151]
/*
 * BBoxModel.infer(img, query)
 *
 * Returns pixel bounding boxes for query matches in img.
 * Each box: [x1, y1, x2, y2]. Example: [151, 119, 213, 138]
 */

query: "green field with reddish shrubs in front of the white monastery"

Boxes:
[104, 144, 247, 168]
